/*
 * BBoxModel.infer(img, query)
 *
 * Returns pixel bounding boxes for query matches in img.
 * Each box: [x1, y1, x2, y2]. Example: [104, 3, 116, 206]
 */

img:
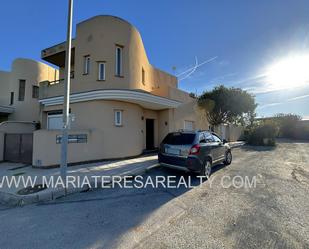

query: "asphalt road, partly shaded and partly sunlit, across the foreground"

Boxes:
[0, 142, 309, 249]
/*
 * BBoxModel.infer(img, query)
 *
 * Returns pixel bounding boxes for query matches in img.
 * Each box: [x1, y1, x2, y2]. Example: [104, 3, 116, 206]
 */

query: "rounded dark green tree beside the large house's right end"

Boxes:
[198, 85, 257, 126]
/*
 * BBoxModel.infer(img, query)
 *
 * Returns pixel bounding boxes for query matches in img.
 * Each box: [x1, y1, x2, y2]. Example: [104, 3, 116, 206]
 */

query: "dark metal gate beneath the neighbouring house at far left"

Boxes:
[4, 134, 33, 164]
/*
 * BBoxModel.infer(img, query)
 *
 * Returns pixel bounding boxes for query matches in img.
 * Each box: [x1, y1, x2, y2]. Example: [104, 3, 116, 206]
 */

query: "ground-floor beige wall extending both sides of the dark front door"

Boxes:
[33, 100, 208, 166]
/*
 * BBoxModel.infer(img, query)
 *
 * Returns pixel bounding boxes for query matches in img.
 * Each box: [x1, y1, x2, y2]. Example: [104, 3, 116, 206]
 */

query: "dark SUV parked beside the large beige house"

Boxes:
[159, 131, 232, 178]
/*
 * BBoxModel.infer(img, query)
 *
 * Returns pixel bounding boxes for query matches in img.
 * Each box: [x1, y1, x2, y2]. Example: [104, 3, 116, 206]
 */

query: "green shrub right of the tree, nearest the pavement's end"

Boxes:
[244, 124, 278, 146]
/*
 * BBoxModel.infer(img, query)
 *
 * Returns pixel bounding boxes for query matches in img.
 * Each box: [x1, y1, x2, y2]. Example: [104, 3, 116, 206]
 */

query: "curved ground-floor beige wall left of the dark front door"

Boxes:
[33, 100, 151, 166]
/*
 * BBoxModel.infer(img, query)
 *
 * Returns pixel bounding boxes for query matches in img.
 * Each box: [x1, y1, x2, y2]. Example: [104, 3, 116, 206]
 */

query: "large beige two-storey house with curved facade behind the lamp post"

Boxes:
[33, 16, 208, 167]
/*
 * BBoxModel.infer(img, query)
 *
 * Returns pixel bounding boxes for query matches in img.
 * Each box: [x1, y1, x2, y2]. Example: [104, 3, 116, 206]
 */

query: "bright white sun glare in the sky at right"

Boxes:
[267, 55, 309, 89]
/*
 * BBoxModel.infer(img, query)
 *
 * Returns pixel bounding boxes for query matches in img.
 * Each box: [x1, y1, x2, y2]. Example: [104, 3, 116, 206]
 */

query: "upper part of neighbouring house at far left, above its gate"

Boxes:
[0, 58, 59, 122]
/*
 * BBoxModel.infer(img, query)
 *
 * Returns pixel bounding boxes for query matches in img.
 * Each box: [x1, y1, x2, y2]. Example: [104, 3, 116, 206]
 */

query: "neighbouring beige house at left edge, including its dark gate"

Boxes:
[0, 58, 59, 163]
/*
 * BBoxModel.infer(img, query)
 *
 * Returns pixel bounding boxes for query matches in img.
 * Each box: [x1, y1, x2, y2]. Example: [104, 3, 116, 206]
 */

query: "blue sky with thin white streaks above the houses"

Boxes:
[0, 0, 309, 117]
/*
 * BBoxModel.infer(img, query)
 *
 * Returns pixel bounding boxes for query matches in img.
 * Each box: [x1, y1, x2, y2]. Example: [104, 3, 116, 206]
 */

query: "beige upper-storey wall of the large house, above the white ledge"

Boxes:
[42, 16, 177, 98]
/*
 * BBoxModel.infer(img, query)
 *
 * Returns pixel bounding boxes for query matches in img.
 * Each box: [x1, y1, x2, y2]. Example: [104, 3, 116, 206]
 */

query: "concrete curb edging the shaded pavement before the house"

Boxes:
[0, 164, 159, 207]
